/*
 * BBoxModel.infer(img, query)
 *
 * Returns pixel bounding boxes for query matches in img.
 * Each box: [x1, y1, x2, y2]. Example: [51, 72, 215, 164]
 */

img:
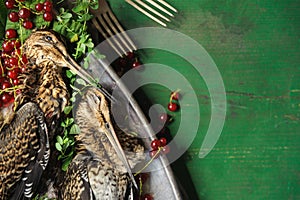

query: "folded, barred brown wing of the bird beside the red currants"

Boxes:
[0, 103, 50, 199]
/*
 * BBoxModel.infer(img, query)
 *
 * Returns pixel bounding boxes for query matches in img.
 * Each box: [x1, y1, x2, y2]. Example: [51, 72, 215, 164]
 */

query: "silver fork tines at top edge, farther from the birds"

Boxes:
[125, 0, 177, 27]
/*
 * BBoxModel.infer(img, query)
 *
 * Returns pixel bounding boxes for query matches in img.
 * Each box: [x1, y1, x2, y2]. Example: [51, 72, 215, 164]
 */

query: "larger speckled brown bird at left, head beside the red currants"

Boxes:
[0, 30, 100, 199]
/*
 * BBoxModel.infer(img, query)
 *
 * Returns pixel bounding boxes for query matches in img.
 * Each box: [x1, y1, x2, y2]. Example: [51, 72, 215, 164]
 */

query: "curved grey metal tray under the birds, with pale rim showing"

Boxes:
[83, 45, 185, 200]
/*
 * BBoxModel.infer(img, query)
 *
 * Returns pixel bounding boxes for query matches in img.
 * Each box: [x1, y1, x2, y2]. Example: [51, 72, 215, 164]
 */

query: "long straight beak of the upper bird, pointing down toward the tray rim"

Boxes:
[65, 55, 114, 101]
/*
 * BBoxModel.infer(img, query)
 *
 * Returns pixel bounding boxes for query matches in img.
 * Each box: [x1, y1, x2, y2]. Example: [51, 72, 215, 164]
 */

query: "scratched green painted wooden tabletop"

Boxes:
[112, 0, 300, 200]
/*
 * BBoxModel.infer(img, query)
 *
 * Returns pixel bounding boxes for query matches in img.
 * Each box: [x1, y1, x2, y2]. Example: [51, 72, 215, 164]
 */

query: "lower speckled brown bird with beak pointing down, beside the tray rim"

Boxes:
[61, 88, 144, 200]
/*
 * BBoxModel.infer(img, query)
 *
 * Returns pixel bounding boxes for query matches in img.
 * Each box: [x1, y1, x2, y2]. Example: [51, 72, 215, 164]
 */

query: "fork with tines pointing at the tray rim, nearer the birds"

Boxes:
[91, 0, 137, 57]
